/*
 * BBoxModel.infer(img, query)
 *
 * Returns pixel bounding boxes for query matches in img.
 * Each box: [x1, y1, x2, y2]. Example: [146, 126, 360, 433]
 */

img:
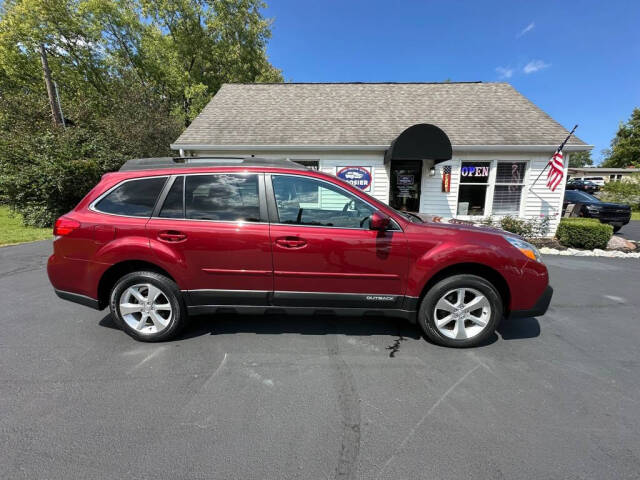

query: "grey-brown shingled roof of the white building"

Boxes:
[172, 83, 585, 149]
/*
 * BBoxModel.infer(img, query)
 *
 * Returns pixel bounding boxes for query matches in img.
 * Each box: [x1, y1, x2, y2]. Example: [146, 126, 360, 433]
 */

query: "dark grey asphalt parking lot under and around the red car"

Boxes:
[0, 242, 640, 479]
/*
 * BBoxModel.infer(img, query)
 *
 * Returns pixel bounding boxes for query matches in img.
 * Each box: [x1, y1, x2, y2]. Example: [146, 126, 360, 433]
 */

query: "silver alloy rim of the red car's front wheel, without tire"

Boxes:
[433, 288, 491, 340]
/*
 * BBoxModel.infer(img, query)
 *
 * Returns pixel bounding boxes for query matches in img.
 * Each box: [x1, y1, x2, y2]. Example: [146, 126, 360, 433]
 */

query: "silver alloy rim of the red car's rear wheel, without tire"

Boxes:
[118, 283, 173, 335]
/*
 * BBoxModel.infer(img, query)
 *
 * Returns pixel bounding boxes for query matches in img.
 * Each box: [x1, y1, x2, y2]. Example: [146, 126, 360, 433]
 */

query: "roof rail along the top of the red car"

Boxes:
[119, 157, 307, 172]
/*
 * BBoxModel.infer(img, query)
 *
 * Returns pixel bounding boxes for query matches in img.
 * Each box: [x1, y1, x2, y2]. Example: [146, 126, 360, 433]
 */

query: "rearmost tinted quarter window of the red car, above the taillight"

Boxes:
[95, 177, 167, 217]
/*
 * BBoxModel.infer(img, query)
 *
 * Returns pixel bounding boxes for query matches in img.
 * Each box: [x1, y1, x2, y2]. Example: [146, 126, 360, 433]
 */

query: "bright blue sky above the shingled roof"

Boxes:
[263, 0, 640, 163]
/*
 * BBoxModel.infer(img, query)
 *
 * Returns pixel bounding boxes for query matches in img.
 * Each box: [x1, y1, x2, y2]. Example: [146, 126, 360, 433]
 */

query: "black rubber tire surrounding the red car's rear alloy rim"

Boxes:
[109, 272, 187, 342]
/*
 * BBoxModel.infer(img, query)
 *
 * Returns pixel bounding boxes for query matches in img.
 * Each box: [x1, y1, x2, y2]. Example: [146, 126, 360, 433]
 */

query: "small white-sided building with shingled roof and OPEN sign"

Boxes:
[171, 83, 591, 234]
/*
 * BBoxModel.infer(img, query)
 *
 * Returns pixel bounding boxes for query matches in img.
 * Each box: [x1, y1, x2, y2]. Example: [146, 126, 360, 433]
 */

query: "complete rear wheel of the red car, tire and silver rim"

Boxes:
[109, 272, 187, 342]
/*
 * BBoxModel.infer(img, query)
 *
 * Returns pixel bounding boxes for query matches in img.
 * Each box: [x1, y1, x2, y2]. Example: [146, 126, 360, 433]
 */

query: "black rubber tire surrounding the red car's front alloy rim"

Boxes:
[418, 274, 504, 348]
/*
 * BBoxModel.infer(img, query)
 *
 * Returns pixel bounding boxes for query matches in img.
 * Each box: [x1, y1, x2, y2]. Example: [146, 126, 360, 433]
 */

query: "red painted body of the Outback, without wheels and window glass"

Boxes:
[48, 159, 551, 346]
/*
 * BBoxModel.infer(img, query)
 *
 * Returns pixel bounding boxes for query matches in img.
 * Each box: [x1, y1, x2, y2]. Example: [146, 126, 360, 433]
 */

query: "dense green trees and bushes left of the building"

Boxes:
[0, 0, 282, 225]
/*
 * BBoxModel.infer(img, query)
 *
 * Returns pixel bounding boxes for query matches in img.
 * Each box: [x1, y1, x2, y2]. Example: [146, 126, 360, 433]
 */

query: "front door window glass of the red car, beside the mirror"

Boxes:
[272, 175, 374, 229]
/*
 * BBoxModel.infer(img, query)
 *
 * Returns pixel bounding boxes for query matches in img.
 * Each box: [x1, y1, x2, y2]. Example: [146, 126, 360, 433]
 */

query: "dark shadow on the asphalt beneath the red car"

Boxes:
[99, 313, 540, 346]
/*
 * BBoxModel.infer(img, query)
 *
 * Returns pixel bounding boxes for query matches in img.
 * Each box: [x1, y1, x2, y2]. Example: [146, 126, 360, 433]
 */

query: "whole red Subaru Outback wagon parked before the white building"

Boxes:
[48, 158, 553, 347]
